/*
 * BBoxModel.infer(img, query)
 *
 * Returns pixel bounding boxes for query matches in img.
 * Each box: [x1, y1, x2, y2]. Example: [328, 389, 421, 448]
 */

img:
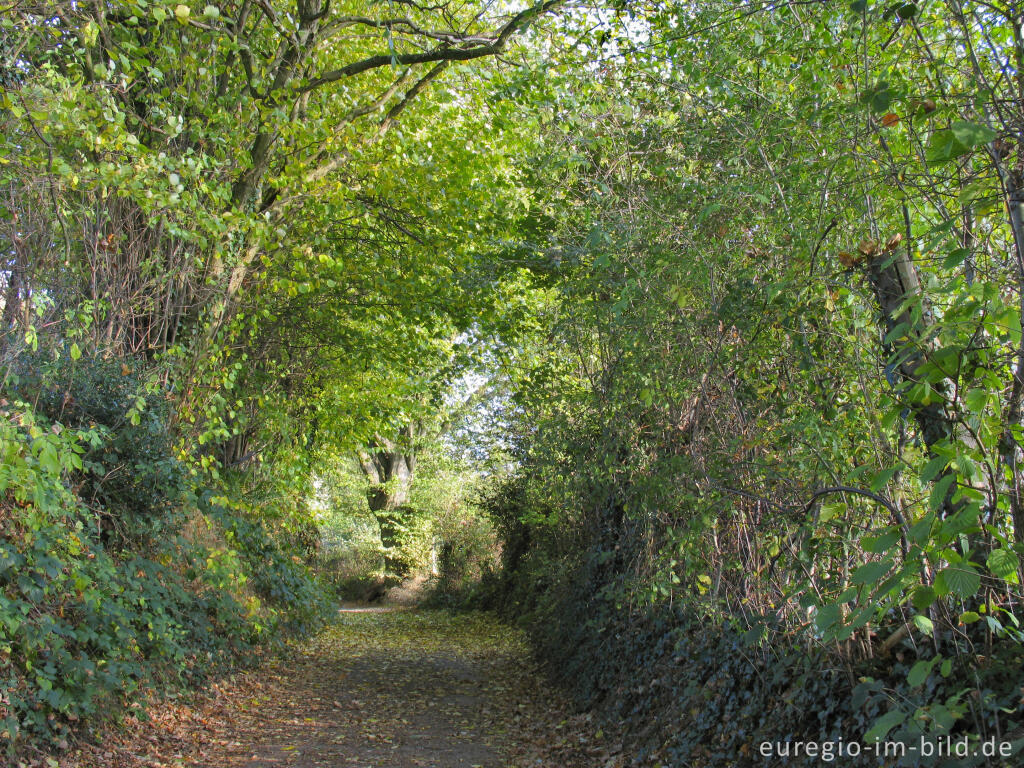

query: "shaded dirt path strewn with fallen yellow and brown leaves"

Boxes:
[70, 609, 620, 768]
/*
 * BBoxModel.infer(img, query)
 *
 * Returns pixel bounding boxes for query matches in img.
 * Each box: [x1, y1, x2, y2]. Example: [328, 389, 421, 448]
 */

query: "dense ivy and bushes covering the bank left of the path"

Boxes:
[0, 378, 324, 754]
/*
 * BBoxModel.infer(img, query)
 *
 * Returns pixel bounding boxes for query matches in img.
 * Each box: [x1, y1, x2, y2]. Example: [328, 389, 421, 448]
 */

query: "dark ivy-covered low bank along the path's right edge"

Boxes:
[485, 478, 1024, 768]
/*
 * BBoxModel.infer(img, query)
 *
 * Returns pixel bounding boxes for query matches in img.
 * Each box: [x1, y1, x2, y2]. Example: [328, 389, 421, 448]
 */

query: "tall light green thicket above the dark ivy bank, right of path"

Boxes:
[473, 3, 1024, 764]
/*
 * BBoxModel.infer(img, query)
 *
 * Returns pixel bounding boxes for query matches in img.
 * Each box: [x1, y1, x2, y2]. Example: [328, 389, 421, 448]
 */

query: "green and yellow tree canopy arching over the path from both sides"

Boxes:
[0, 0, 1024, 761]
